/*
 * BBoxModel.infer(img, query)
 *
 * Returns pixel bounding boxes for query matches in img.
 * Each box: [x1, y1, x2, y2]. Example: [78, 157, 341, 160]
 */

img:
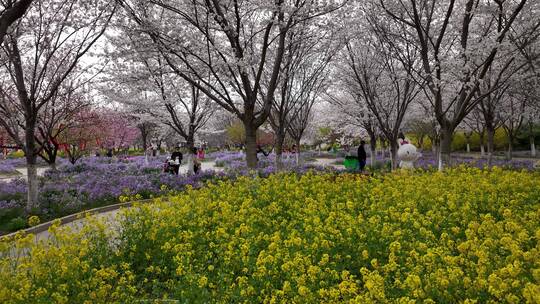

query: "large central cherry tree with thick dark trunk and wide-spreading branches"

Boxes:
[118, 0, 348, 168]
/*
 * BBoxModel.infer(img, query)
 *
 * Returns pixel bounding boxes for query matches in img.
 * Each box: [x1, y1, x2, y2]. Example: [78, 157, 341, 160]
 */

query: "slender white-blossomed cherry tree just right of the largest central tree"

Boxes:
[261, 26, 341, 168]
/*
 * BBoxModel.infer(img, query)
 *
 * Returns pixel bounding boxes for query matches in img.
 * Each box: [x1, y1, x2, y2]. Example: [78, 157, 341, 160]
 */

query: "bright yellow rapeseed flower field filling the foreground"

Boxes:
[0, 167, 540, 303]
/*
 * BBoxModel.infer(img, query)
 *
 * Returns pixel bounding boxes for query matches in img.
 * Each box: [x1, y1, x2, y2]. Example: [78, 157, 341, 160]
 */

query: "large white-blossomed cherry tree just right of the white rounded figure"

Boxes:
[376, 0, 538, 167]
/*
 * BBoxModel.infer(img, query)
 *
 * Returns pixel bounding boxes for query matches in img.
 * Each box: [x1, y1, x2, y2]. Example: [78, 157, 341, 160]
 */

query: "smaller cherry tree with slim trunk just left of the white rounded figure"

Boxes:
[342, 18, 422, 169]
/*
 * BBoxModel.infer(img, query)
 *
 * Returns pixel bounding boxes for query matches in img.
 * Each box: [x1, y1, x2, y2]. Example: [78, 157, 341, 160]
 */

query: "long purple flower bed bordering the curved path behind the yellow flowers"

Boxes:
[0, 153, 329, 230]
